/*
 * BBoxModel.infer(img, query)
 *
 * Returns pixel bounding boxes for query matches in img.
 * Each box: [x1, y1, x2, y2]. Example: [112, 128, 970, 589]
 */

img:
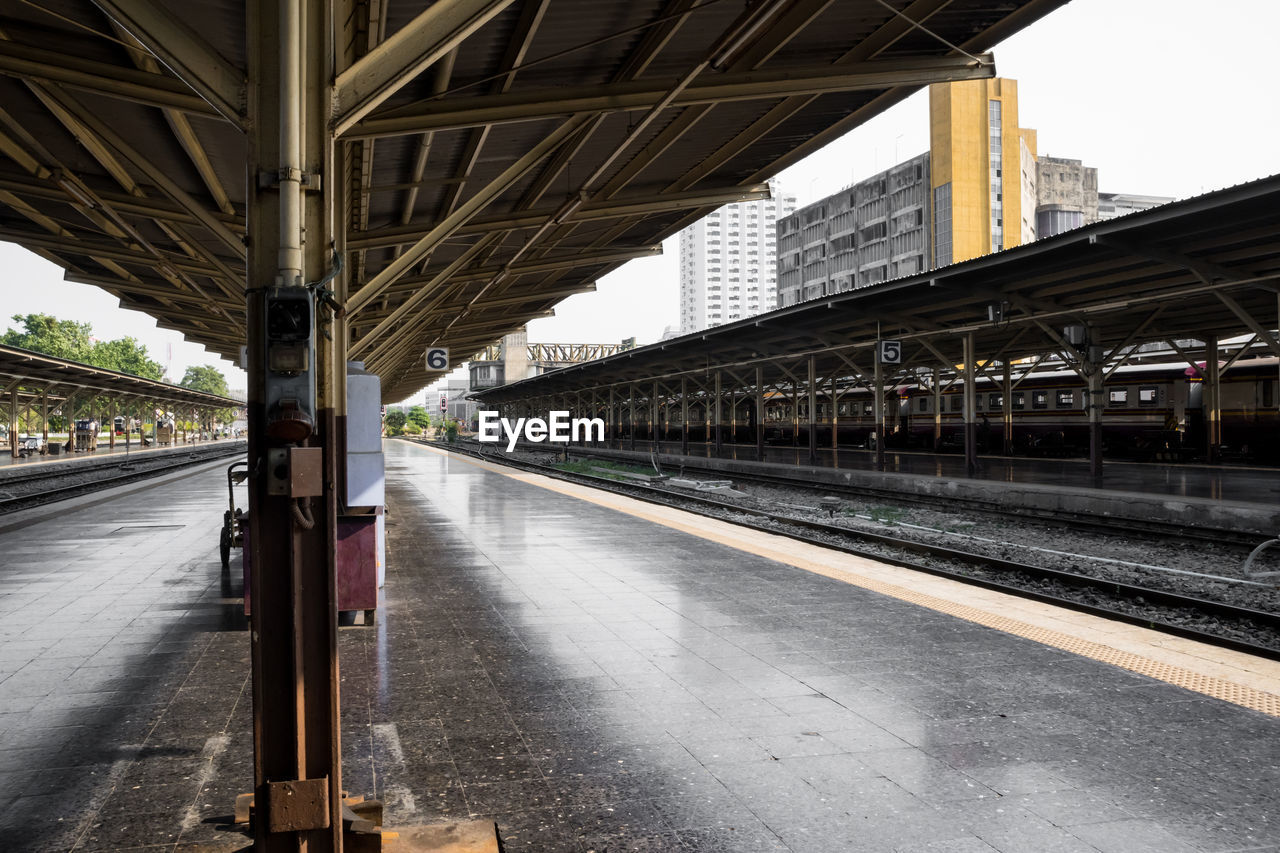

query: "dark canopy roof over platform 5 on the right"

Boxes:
[475, 175, 1280, 403]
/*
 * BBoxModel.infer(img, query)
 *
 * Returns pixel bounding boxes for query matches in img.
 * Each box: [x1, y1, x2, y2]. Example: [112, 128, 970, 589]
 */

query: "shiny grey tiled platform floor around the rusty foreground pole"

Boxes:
[0, 442, 1280, 853]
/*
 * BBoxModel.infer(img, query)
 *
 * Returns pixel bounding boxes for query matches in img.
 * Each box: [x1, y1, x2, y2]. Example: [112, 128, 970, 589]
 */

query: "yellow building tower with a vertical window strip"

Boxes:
[929, 77, 1036, 266]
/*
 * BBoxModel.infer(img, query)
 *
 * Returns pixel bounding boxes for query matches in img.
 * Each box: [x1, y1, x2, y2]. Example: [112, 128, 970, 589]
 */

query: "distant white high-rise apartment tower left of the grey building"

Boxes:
[680, 181, 796, 334]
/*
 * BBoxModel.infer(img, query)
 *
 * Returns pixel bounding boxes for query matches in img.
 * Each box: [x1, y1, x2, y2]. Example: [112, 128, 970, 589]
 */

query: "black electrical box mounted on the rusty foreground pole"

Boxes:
[265, 287, 316, 442]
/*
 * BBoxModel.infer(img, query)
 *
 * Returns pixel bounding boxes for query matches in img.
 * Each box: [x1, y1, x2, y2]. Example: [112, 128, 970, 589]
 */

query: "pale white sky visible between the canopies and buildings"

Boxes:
[0, 0, 1280, 400]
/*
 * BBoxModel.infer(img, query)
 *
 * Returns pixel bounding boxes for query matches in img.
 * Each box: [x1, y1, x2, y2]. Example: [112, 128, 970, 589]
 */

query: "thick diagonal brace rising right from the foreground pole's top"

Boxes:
[337, 0, 513, 134]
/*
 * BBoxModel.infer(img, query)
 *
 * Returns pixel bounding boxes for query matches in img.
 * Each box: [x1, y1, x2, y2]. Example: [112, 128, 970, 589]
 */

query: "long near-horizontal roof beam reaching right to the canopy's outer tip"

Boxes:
[344, 54, 996, 138]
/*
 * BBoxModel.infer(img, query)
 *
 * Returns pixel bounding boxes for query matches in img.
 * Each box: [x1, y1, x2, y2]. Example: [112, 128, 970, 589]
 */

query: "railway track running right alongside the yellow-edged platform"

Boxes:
[427, 444, 1280, 660]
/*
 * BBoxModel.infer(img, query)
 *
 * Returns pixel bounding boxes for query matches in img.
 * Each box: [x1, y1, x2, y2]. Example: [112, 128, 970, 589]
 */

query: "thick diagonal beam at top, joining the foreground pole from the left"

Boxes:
[92, 0, 247, 129]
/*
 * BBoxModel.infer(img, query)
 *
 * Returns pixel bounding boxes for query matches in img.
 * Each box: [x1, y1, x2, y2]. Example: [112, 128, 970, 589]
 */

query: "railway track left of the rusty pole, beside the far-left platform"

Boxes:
[0, 442, 246, 516]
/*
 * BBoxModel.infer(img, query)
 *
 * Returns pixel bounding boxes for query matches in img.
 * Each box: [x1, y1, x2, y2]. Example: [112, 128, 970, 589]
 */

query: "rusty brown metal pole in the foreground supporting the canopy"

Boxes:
[246, 0, 346, 853]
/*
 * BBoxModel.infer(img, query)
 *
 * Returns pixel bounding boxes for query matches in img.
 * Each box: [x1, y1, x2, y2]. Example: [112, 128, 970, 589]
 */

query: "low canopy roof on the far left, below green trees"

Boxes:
[0, 347, 244, 409]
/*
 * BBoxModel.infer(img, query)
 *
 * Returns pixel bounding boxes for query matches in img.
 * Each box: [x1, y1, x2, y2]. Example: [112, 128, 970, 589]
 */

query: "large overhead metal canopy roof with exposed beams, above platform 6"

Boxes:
[0, 0, 1065, 398]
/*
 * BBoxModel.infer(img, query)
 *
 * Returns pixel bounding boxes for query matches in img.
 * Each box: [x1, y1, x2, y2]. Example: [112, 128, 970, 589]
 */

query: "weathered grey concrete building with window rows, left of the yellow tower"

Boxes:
[778, 154, 933, 307]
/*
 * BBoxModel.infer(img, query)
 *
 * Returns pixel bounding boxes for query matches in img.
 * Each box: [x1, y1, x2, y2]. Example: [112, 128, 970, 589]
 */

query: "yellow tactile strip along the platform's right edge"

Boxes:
[428, 448, 1280, 717]
